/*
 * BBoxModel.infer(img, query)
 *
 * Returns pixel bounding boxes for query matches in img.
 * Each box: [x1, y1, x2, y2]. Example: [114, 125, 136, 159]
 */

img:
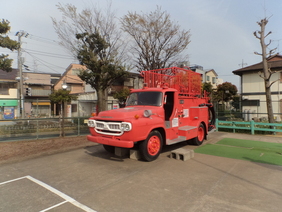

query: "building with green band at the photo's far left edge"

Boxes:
[0, 69, 20, 119]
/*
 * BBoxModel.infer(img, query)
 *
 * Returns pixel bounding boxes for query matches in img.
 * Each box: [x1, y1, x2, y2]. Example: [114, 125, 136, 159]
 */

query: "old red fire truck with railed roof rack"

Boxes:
[87, 67, 215, 161]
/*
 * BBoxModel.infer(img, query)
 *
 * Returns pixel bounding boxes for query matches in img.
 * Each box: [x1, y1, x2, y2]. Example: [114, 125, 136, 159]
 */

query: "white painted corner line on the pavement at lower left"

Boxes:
[0, 175, 97, 212]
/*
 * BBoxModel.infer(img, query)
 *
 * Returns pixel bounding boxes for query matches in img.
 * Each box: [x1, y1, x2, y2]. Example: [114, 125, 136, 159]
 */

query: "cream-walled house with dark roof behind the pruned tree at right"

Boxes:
[233, 54, 282, 121]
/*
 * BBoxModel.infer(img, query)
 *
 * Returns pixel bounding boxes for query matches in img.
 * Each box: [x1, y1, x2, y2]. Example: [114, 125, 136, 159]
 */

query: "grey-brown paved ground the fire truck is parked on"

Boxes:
[0, 132, 282, 212]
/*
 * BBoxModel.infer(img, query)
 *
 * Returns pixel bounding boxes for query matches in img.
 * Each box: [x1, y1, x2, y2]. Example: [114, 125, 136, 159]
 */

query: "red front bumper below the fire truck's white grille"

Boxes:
[87, 135, 134, 148]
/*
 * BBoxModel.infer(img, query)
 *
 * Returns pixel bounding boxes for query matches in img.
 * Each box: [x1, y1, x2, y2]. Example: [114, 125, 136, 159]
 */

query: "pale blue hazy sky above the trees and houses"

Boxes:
[0, 0, 282, 89]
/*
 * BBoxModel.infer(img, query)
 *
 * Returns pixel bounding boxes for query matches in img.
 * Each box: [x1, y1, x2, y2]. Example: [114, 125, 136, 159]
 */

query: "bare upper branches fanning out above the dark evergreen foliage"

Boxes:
[52, 3, 126, 62]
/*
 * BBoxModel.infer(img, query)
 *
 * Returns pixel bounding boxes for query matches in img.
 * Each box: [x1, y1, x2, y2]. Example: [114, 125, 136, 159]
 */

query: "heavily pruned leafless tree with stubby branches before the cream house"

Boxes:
[254, 18, 276, 123]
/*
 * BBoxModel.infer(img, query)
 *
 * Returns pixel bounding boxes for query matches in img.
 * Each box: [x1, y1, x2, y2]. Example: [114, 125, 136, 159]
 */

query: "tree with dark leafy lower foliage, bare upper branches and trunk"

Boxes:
[52, 4, 127, 112]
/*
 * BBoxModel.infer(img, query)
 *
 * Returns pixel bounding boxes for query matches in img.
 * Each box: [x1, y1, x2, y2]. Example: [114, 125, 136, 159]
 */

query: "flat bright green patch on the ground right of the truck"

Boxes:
[194, 138, 282, 166]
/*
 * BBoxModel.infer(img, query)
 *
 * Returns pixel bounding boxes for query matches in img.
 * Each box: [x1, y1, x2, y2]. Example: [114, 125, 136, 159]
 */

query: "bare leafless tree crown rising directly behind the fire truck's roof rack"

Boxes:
[121, 7, 190, 71]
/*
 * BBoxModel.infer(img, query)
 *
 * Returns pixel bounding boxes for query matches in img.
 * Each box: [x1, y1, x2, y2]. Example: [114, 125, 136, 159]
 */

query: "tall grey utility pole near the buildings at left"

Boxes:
[16, 30, 28, 119]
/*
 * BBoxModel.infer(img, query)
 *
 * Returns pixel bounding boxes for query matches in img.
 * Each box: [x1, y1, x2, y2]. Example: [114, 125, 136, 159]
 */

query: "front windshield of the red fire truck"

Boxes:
[126, 92, 162, 106]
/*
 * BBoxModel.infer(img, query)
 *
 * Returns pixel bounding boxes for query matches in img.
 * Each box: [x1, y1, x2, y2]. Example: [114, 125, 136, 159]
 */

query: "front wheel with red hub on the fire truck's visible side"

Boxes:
[139, 130, 163, 161]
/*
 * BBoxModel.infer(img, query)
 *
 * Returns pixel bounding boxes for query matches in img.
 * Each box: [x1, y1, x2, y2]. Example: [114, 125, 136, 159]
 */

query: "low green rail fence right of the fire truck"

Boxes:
[215, 119, 282, 135]
